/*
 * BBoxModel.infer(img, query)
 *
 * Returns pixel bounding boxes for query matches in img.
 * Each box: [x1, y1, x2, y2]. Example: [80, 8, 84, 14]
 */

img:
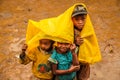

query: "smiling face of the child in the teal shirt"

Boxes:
[57, 42, 70, 53]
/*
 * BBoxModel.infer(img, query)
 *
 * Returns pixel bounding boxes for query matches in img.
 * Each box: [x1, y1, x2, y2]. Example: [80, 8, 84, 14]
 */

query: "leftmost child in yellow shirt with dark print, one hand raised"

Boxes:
[20, 39, 54, 80]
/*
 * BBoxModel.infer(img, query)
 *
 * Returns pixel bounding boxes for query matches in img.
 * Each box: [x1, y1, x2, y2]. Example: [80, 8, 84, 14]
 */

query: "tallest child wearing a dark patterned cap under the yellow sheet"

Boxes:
[72, 5, 90, 80]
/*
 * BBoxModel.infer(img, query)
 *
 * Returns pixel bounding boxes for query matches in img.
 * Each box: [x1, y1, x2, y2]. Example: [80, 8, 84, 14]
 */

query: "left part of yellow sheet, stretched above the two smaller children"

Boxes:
[26, 3, 74, 48]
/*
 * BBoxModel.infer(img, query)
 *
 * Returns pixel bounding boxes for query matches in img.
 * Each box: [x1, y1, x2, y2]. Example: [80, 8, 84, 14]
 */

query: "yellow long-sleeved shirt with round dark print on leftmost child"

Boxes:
[20, 47, 53, 80]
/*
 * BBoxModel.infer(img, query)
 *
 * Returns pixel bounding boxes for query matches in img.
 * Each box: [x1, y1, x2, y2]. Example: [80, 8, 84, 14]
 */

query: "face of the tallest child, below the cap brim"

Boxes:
[72, 15, 86, 30]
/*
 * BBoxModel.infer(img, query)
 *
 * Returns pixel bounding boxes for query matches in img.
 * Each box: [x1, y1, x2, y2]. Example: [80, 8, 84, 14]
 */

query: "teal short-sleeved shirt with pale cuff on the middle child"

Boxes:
[49, 50, 76, 80]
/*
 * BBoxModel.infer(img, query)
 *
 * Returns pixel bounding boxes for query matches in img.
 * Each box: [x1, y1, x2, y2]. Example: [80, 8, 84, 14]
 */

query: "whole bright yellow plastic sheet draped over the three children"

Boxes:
[26, 3, 101, 64]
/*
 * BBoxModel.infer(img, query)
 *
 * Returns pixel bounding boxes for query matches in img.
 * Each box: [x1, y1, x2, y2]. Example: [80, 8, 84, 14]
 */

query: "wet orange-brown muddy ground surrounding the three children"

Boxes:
[0, 0, 120, 80]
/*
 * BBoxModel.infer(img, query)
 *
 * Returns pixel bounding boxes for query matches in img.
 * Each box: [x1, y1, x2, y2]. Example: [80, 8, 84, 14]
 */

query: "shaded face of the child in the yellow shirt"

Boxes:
[39, 39, 53, 51]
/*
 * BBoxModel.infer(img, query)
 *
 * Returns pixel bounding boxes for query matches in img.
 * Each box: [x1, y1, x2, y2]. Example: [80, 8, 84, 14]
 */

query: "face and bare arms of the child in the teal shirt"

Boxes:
[52, 43, 79, 75]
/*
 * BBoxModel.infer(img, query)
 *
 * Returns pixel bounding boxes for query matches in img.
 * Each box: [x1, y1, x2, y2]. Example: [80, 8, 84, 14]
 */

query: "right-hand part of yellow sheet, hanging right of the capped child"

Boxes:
[75, 4, 101, 64]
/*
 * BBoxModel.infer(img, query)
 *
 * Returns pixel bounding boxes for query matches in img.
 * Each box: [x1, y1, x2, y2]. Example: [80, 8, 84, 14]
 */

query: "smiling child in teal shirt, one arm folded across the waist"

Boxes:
[48, 42, 79, 80]
